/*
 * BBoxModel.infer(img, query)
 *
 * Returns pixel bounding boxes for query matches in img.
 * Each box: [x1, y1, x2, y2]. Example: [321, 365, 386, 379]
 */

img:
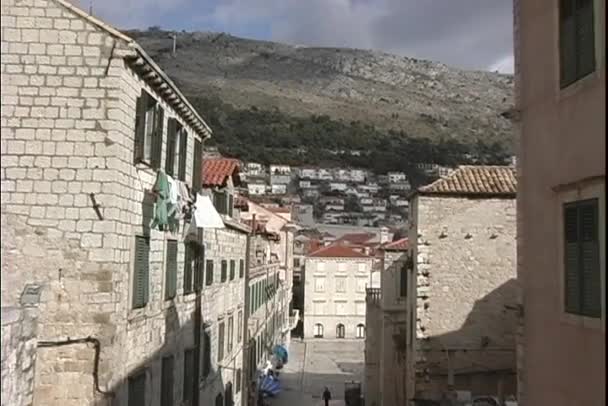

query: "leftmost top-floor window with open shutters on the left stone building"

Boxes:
[135, 90, 164, 169]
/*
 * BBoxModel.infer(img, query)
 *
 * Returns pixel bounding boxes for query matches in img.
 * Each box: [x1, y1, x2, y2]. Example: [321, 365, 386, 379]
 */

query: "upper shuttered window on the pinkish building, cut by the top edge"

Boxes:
[559, 0, 595, 88]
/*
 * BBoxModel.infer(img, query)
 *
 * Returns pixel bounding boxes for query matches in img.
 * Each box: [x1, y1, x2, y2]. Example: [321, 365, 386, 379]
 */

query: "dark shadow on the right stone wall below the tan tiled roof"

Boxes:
[416, 278, 519, 398]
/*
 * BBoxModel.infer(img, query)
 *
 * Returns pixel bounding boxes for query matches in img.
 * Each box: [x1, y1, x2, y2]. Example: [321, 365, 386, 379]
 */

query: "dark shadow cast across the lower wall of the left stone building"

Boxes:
[95, 306, 228, 406]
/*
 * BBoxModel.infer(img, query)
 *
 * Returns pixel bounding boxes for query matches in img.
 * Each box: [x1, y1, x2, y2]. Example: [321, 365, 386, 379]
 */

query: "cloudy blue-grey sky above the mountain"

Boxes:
[76, 0, 513, 73]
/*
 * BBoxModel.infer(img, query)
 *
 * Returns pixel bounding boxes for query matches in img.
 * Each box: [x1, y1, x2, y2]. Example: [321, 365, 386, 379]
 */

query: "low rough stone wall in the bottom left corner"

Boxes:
[2, 307, 38, 406]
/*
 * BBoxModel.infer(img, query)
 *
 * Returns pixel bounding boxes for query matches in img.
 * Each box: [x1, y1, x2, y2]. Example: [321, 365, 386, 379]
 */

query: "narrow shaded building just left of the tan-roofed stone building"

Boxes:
[364, 238, 412, 406]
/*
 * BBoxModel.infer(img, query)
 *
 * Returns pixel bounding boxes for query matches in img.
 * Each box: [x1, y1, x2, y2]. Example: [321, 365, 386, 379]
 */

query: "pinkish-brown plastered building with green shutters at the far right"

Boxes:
[513, 0, 606, 406]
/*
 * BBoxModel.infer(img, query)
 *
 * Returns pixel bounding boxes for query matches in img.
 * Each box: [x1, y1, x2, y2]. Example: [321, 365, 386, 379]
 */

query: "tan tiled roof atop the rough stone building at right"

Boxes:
[418, 165, 517, 197]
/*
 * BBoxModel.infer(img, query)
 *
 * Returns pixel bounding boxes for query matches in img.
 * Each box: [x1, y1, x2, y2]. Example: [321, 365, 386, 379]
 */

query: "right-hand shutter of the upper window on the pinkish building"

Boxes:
[576, 0, 595, 79]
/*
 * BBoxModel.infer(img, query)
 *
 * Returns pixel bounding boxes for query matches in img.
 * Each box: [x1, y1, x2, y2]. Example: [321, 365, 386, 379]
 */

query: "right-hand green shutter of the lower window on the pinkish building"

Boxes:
[579, 199, 602, 317]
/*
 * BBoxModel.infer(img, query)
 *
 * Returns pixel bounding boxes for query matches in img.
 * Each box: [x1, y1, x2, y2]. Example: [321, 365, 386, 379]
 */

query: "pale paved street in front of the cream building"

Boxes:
[271, 340, 364, 406]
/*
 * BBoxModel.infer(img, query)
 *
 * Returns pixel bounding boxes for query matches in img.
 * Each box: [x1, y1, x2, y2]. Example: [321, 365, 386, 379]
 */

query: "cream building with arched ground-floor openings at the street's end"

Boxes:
[304, 245, 373, 339]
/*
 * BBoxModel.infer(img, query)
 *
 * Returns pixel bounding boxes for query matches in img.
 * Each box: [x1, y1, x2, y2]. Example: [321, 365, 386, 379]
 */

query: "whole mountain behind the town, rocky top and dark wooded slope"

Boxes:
[127, 29, 514, 171]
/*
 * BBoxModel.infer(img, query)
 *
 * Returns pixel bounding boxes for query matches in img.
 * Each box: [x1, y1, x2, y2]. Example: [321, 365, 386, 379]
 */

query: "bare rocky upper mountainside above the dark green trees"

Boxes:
[128, 30, 513, 150]
